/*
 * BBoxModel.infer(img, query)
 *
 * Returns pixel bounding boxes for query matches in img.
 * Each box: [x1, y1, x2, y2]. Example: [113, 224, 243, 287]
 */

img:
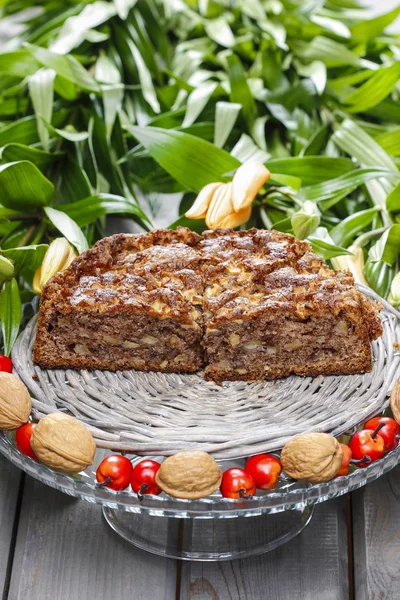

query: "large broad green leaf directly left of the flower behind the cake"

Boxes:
[128, 127, 240, 192]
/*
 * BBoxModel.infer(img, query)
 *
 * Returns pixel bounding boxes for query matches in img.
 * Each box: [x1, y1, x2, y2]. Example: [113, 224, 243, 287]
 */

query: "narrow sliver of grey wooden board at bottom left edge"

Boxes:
[0, 456, 21, 595]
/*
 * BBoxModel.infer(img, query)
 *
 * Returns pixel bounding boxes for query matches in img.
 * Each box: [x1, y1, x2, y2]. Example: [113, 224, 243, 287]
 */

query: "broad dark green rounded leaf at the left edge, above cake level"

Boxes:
[0, 160, 54, 212]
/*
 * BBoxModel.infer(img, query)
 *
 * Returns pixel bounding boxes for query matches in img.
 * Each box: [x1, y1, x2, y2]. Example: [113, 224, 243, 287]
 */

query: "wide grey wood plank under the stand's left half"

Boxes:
[9, 478, 176, 600]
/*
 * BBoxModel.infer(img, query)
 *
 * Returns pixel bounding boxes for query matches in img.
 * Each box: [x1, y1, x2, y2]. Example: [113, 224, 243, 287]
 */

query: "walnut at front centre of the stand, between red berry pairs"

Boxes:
[156, 451, 222, 500]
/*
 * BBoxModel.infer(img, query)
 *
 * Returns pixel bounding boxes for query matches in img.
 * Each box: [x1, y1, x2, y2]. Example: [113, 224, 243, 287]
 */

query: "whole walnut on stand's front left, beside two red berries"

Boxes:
[31, 413, 96, 473]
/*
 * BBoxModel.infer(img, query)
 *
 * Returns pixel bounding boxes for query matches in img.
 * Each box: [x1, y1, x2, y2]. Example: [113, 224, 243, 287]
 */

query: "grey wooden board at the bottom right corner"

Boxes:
[352, 467, 400, 600]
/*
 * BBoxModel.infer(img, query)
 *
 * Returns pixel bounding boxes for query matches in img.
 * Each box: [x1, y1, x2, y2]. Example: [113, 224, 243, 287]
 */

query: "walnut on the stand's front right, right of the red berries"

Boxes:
[281, 433, 343, 483]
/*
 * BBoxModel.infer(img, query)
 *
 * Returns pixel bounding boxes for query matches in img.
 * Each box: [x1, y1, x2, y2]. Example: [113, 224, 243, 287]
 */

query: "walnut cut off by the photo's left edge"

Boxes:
[0, 372, 32, 431]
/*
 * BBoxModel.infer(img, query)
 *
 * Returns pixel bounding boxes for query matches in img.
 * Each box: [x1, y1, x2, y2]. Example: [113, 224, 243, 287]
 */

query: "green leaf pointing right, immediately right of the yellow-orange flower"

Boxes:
[267, 156, 354, 186]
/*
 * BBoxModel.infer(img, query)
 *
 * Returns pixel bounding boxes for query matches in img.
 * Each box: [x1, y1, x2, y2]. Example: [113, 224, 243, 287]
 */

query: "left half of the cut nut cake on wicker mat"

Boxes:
[34, 228, 203, 372]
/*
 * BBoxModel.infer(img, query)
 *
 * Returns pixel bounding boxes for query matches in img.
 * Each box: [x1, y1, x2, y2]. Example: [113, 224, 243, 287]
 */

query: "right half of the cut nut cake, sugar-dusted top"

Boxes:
[201, 230, 382, 383]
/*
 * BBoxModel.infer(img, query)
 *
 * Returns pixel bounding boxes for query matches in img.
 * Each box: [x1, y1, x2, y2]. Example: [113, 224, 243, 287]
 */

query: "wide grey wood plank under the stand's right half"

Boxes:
[181, 498, 349, 600]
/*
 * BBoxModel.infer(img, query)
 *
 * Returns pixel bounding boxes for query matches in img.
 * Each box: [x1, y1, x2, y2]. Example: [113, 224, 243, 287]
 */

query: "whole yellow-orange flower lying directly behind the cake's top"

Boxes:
[186, 161, 270, 229]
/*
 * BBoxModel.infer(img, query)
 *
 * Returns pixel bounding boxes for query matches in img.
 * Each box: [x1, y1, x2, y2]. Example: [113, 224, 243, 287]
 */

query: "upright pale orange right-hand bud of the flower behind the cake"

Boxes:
[232, 161, 271, 212]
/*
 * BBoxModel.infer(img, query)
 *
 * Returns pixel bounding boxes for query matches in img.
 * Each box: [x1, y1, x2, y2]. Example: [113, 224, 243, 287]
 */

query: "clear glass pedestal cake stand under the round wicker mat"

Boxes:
[0, 432, 400, 561]
